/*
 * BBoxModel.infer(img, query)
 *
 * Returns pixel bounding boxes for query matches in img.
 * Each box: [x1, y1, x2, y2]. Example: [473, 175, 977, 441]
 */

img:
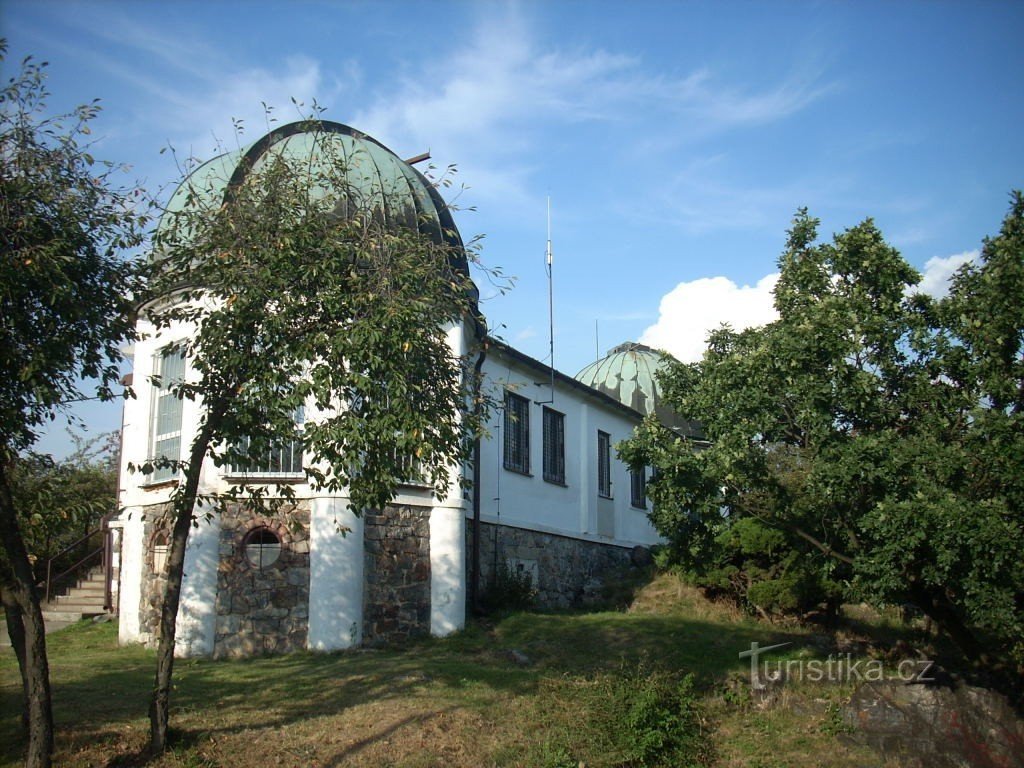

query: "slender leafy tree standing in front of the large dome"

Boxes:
[141, 120, 495, 752]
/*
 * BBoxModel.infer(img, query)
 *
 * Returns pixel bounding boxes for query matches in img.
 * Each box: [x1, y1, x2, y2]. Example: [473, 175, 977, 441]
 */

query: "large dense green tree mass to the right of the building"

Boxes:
[623, 195, 1024, 659]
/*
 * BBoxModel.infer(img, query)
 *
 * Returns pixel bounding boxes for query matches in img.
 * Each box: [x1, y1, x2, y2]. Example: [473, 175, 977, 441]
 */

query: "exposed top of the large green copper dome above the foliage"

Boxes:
[159, 120, 468, 271]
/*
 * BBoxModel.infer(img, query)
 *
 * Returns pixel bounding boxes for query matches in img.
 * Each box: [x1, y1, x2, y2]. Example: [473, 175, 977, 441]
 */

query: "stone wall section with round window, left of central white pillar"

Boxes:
[213, 503, 309, 657]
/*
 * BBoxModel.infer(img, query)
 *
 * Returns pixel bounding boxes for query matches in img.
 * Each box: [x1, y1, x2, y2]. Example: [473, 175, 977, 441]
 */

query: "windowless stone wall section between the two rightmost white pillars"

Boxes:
[362, 506, 430, 645]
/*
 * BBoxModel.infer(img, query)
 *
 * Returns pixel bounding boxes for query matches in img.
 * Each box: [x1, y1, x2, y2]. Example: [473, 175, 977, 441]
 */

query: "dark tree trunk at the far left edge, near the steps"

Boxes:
[0, 461, 53, 768]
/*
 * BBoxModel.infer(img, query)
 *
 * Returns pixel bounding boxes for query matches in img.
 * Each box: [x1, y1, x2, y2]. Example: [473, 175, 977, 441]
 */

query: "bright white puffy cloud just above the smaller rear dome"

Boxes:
[640, 273, 778, 362]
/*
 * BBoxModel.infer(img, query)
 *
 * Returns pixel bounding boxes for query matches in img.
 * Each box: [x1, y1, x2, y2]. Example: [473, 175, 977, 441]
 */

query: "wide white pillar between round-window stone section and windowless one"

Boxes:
[307, 498, 362, 650]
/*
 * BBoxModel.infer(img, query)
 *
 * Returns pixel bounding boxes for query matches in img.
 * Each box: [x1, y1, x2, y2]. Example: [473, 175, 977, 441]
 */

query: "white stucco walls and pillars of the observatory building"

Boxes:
[119, 301, 658, 655]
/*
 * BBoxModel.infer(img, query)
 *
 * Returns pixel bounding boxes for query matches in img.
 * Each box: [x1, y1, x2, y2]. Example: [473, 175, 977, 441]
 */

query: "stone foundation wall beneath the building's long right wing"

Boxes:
[466, 522, 633, 609]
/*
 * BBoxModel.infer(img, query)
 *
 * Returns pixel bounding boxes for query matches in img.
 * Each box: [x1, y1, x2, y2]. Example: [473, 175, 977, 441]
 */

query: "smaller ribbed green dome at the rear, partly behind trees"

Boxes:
[575, 341, 700, 437]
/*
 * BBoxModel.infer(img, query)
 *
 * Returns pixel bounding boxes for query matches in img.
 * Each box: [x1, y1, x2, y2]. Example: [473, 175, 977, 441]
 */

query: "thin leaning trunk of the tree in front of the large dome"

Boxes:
[150, 413, 219, 755]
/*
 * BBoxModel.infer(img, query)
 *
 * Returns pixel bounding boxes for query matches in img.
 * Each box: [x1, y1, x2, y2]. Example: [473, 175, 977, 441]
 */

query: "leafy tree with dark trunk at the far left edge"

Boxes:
[0, 44, 144, 766]
